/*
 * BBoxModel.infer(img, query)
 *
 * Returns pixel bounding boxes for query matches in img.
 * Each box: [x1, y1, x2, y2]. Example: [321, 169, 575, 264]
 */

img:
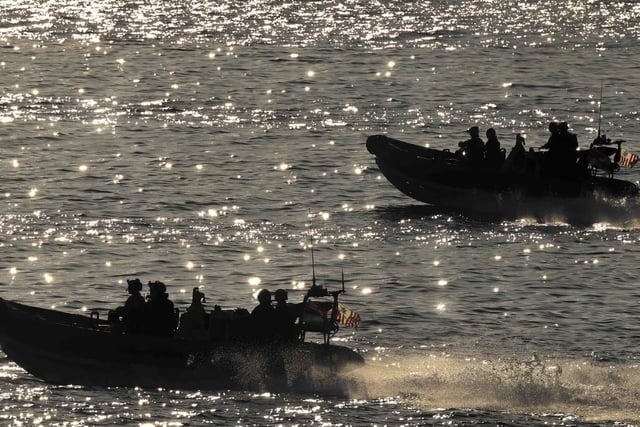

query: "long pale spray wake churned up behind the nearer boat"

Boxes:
[342, 354, 640, 422]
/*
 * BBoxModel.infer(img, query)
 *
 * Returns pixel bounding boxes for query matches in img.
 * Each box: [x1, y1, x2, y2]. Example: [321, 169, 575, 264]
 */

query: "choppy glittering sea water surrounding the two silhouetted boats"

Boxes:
[0, 0, 640, 426]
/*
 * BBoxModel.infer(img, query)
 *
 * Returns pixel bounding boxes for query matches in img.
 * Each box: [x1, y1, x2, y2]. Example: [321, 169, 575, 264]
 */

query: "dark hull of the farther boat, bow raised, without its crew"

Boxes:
[366, 135, 638, 215]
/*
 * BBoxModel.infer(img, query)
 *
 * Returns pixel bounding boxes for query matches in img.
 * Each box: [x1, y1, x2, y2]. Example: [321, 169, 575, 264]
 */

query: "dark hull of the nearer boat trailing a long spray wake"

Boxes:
[0, 293, 364, 391]
